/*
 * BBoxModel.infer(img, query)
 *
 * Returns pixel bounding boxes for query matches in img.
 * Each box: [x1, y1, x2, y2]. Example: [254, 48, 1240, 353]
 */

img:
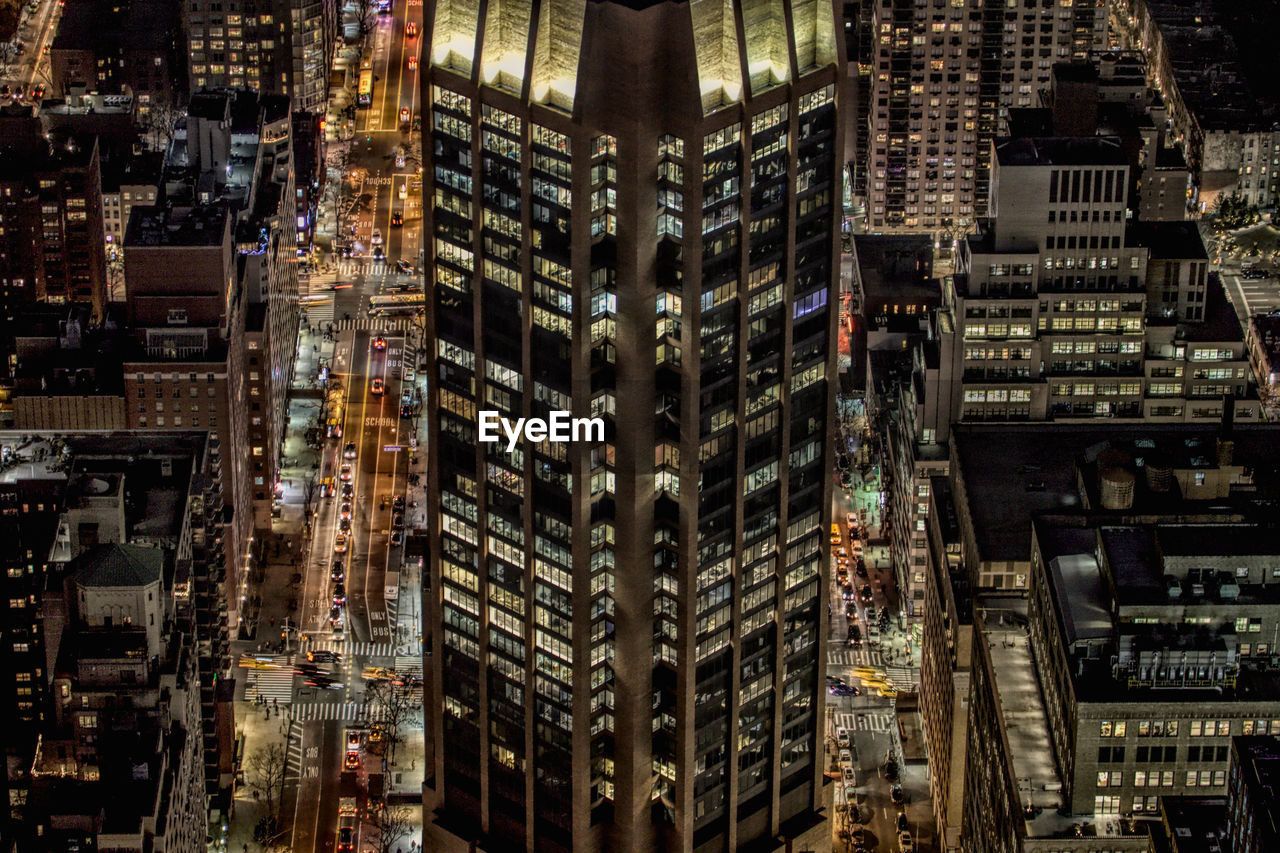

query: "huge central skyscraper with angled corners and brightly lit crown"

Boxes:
[422, 0, 842, 850]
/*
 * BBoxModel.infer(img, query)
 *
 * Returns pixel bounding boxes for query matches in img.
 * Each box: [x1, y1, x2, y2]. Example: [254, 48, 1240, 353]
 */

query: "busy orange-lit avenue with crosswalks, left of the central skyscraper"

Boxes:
[229, 0, 428, 853]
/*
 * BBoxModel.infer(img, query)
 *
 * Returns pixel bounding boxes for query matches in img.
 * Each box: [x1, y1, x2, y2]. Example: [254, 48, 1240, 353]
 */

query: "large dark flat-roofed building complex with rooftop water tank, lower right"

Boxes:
[920, 423, 1280, 853]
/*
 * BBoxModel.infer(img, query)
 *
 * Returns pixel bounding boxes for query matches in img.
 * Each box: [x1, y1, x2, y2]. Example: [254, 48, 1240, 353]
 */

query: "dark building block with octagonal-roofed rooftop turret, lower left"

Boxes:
[0, 432, 227, 850]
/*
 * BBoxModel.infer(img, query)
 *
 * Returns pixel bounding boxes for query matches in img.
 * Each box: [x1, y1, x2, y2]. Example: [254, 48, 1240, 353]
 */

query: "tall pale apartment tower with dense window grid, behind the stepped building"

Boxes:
[850, 0, 1107, 233]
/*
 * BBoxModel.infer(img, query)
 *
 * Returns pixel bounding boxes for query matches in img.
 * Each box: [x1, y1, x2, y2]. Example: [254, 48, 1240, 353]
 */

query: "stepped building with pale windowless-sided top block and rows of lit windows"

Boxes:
[945, 137, 1260, 421]
